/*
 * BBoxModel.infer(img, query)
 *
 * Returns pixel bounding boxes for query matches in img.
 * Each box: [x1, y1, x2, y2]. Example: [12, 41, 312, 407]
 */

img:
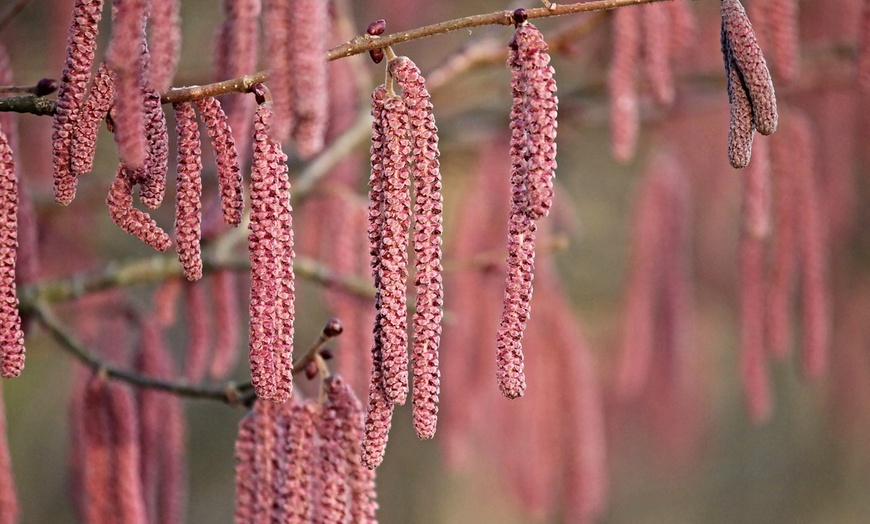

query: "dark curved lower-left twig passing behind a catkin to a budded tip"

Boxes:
[30, 304, 341, 407]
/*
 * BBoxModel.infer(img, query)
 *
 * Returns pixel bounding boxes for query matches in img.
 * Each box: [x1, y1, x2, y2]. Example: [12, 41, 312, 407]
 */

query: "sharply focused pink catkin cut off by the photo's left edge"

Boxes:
[0, 129, 24, 378]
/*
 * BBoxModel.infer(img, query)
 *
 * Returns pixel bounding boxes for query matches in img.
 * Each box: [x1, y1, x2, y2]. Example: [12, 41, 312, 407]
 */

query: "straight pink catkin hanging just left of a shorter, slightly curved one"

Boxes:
[174, 102, 202, 281]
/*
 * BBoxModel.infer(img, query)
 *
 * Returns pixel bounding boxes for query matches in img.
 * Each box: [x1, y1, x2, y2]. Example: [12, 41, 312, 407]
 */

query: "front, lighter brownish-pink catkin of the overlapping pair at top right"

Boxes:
[721, 0, 778, 135]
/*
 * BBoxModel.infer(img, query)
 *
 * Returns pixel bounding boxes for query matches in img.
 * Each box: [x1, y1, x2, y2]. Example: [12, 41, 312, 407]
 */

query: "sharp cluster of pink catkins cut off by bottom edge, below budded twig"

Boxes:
[235, 376, 378, 523]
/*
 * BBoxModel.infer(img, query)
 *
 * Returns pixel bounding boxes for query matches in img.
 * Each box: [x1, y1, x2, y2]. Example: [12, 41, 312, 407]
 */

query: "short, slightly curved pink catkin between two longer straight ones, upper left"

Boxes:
[196, 97, 244, 226]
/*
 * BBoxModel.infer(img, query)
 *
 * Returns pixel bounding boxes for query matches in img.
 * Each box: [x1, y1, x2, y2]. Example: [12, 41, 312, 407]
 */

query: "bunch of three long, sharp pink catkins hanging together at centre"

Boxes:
[363, 50, 443, 467]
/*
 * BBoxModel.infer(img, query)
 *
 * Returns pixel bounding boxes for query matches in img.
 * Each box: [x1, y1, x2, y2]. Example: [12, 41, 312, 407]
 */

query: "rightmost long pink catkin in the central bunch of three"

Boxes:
[390, 57, 444, 439]
